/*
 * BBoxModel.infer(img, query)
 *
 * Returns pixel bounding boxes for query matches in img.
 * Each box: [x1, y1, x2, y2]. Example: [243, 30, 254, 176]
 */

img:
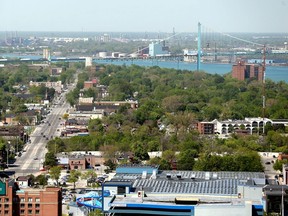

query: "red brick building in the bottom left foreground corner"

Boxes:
[0, 179, 62, 216]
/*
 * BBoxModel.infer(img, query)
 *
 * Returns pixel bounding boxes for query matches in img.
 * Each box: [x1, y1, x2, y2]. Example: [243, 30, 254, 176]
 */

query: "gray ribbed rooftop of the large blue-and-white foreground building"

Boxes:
[113, 171, 265, 195]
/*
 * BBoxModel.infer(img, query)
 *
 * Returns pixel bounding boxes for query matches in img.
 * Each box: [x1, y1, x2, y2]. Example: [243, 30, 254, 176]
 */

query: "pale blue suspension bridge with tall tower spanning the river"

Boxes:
[0, 23, 288, 70]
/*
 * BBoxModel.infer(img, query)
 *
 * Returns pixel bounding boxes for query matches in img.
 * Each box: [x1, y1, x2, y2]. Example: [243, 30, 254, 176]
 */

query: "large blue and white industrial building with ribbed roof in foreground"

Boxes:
[102, 165, 265, 216]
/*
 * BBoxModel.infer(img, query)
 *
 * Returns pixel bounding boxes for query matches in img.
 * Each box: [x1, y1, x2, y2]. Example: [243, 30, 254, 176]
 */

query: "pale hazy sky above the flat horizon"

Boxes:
[0, 0, 288, 33]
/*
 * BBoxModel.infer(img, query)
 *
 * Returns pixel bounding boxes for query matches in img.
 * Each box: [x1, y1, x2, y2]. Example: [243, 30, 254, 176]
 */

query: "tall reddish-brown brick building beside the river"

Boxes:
[232, 61, 264, 81]
